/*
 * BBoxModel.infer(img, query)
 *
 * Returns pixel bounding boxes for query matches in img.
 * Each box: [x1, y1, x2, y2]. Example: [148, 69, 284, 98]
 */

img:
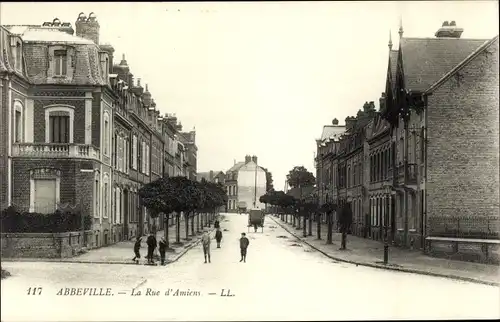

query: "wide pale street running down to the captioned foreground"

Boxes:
[1, 215, 500, 321]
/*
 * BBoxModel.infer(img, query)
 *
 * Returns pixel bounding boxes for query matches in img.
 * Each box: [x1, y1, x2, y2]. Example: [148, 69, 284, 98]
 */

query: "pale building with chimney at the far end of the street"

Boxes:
[224, 155, 267, 212]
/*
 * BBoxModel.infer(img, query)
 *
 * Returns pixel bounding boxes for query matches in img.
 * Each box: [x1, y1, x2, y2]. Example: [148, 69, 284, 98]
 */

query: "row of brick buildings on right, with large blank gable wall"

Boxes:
[316, 22, 500, 255]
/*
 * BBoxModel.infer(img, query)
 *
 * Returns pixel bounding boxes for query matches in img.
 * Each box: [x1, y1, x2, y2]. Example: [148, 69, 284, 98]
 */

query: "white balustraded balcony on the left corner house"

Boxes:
[12, 143, 100, 160]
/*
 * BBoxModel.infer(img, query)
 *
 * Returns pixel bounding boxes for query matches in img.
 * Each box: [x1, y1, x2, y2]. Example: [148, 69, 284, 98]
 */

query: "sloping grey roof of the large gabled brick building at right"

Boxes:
[399, 38, 488, 92]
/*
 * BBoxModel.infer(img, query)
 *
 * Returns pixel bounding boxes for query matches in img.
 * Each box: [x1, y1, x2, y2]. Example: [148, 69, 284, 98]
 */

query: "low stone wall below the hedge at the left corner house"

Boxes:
[0, 231, 94, 258]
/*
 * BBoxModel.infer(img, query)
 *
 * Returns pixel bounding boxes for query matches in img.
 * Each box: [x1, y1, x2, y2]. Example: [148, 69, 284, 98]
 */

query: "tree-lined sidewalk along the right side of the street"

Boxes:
[269, 216, 500, 286]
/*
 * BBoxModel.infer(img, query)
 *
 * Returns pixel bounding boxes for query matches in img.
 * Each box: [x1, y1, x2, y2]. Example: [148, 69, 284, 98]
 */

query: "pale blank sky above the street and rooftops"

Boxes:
[0, 1, 499, 190]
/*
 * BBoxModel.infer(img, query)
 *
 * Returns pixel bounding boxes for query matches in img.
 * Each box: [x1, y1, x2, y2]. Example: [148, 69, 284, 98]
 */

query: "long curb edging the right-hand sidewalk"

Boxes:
[271, 217, 500, 286]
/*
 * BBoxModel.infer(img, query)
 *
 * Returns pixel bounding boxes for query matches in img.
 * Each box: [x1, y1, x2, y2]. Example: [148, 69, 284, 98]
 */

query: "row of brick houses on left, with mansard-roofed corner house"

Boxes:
[0, 13, 196, 247]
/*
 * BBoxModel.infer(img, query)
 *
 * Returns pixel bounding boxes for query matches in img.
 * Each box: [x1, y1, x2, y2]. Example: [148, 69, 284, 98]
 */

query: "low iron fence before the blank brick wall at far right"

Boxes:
[428, 216, 500, 239]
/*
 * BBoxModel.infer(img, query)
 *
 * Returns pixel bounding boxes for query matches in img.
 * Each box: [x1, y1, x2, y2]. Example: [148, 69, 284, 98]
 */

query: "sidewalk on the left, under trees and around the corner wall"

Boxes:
[2, 215, 223, 265]
